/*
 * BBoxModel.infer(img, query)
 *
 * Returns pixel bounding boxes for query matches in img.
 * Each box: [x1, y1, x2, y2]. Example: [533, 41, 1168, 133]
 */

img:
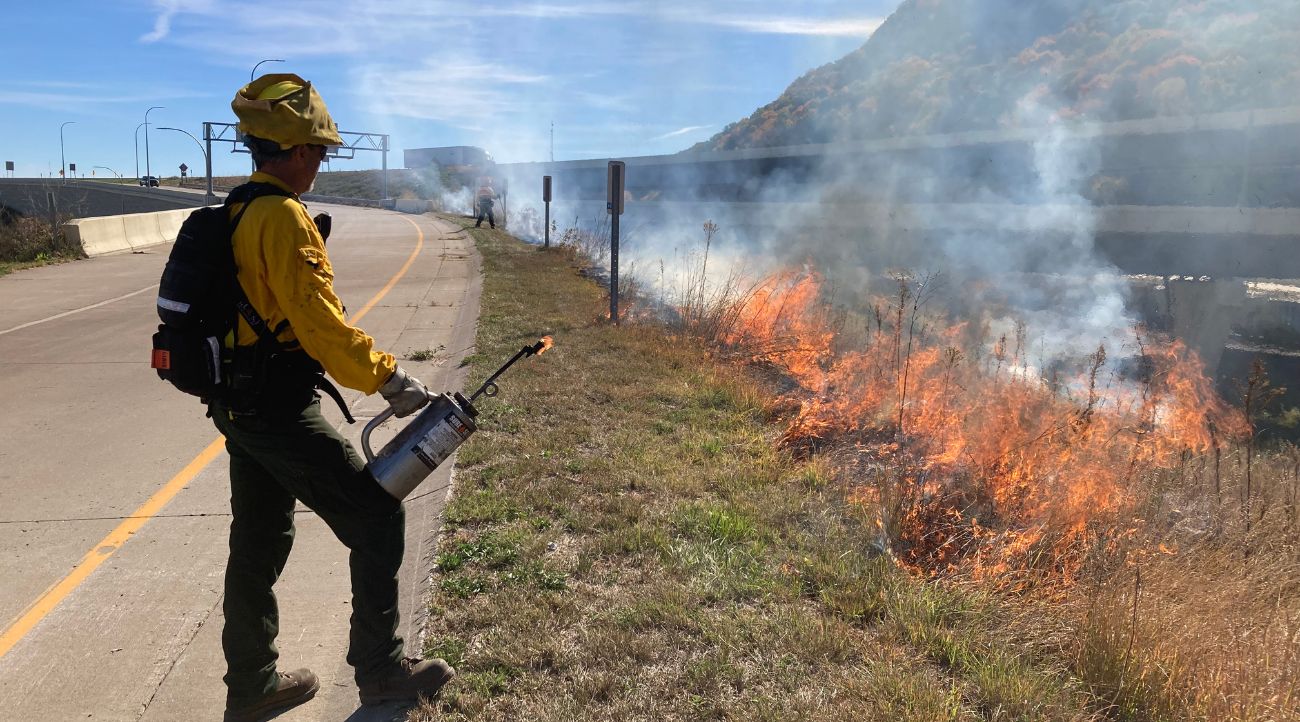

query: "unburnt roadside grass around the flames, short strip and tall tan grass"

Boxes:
[411, 215, 1300, 722]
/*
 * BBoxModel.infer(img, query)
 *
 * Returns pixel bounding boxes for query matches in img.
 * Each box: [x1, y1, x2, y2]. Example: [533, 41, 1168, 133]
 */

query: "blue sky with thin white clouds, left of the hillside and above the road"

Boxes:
[0, 0, 898, 177]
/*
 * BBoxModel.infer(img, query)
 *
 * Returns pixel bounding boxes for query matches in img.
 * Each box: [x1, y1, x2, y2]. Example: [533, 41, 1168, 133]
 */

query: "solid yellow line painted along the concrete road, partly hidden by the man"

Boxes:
[0, 212, 424, 657]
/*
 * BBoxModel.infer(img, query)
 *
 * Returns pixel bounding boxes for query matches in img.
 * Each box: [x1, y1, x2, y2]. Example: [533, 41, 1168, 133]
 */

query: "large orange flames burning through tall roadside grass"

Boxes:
[723, 273, 1247, 576]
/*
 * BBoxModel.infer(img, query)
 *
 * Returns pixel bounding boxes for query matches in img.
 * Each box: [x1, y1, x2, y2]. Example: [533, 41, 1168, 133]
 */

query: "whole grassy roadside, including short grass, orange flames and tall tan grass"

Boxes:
[421, 217, 1300, 722]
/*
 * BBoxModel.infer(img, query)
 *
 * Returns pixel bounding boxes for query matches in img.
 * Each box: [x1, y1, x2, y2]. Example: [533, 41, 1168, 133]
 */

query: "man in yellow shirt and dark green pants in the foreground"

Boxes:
[208, 74, 455, 722]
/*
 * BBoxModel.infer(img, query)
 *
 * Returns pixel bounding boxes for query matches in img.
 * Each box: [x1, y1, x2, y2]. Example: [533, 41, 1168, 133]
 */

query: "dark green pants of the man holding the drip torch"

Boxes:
[209, 401, 406, 702]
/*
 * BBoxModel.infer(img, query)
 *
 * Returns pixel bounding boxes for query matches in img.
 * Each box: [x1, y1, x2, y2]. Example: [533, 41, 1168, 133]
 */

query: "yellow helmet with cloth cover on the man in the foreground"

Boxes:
[230, 73, 343, 150]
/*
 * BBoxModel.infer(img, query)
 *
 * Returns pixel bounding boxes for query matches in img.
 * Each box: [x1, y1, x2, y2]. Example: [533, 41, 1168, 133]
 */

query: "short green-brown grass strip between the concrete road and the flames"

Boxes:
[411, 219, 1105, 722]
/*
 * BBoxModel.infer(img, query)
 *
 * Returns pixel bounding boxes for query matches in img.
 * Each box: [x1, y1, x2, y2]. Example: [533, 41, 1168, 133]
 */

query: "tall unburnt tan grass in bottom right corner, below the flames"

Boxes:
[1060, 449, 1300, 722]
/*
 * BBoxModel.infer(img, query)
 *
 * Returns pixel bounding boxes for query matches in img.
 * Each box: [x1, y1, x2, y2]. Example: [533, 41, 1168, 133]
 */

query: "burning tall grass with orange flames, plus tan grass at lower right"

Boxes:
[688, 266, 1300, 719]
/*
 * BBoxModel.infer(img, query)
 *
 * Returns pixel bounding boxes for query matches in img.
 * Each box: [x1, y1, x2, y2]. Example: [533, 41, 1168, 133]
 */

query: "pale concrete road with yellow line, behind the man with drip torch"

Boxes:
[0, 206, 480, 722]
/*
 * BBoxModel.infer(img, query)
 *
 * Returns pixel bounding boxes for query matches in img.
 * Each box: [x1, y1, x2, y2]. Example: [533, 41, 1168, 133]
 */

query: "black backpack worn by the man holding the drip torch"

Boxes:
[150, 183, 289, 399]
